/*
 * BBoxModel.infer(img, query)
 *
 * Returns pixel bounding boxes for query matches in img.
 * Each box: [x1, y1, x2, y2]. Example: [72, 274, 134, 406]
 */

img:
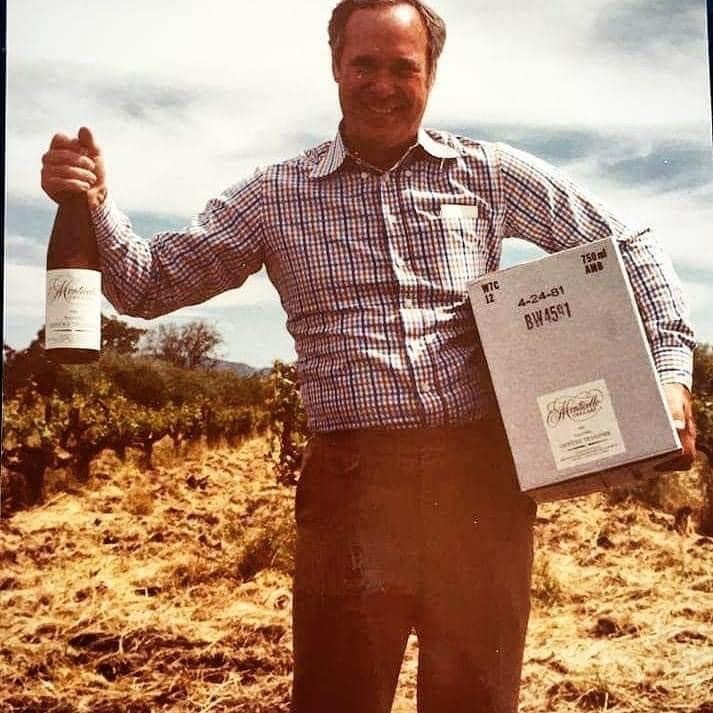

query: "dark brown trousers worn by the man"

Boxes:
[291, 421, 536, 713]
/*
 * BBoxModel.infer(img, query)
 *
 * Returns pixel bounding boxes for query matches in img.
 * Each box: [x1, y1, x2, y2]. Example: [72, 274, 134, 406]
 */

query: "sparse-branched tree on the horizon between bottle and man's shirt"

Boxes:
[146, 320, 223, 369]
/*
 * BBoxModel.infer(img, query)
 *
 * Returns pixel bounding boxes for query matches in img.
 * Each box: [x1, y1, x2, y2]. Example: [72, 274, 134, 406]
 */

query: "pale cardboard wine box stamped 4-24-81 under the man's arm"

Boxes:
[468, 239, 681, 501]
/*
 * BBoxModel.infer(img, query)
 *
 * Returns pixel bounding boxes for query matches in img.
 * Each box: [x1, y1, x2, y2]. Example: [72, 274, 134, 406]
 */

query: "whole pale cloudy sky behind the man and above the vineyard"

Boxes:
[4, 0, 713, 367]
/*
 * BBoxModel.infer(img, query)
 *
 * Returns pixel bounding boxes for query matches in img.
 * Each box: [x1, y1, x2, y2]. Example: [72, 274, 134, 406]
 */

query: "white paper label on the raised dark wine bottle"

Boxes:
[45, 269, 101, 350]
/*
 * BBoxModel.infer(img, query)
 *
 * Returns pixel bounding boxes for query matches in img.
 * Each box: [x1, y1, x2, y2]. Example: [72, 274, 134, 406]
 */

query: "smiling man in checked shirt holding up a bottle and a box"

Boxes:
[42, 0, 694, 713]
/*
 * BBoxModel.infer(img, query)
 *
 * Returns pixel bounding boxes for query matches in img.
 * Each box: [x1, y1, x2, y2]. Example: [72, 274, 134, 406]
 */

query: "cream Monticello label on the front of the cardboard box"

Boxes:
[537, 379, 626, 470]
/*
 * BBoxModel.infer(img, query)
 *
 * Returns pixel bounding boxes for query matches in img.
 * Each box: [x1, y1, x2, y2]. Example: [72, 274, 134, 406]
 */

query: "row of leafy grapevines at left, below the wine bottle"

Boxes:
[2, 355, 262, 513]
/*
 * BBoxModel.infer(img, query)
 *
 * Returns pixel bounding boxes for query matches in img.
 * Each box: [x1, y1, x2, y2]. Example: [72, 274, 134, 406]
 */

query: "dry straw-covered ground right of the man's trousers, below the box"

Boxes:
[521, 462, 713, 713]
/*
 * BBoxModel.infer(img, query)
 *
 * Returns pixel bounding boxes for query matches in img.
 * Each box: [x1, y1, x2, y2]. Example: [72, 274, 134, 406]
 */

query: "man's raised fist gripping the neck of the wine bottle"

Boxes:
[41, 126, 106, 208]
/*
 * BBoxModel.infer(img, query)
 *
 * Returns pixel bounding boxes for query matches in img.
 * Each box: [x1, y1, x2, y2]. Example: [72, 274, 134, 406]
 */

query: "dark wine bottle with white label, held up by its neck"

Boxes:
[45, 193, 101, 364]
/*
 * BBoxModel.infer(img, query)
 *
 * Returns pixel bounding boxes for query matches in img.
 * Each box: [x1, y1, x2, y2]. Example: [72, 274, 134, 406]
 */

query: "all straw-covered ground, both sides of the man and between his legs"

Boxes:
[0, 439, 713, 713]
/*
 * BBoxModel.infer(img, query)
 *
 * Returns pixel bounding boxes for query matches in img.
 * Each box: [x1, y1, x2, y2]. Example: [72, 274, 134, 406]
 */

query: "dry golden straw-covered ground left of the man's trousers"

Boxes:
[0, 441, 292, 713]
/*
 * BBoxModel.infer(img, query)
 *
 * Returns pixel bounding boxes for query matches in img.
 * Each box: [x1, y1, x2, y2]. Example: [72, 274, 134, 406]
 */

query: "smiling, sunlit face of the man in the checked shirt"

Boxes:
[332, 3, 432, 168]
